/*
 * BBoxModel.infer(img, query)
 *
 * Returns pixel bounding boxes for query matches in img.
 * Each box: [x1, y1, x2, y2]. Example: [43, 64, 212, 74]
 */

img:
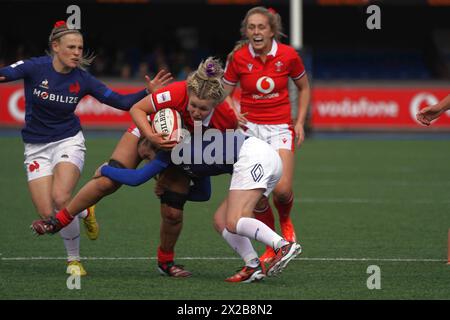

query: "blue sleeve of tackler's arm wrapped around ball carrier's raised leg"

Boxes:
[101, 152, 170, 186]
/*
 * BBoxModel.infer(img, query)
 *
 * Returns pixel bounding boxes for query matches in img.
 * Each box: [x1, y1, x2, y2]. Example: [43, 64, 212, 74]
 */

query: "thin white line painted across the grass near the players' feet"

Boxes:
[1, 257, 447, 262]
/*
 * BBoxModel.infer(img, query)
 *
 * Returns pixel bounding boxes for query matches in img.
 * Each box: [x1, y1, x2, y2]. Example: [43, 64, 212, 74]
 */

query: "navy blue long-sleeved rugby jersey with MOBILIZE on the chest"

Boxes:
[0, 56, 147, 143]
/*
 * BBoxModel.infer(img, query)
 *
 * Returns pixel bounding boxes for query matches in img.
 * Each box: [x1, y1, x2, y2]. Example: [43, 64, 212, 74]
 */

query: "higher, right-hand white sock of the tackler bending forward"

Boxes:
[236, 218, 288, 250]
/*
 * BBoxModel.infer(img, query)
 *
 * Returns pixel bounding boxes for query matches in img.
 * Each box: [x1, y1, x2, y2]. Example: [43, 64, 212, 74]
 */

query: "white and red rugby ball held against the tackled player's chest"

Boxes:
[152, 108, 183, 142]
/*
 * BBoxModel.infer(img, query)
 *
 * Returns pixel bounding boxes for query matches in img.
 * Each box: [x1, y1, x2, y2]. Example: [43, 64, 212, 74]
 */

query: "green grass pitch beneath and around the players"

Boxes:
[0, 134, 450, 300]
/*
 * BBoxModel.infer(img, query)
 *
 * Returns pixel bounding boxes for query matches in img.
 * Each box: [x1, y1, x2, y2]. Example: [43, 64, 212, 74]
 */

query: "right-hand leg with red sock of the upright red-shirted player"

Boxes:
[273, 149, 297, 242]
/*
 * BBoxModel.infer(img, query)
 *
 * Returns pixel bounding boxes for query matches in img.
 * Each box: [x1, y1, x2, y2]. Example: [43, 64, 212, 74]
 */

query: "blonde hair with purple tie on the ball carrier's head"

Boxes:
[187, 57, 226, 104]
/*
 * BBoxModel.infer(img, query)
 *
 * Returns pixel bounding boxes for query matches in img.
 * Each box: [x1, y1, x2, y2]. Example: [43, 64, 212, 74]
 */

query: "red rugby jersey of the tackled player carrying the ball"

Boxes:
[128, 81, 238, 132]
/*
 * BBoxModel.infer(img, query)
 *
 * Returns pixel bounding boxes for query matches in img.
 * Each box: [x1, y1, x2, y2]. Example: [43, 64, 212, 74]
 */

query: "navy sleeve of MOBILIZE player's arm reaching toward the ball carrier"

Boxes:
[88, 75, 148, 111]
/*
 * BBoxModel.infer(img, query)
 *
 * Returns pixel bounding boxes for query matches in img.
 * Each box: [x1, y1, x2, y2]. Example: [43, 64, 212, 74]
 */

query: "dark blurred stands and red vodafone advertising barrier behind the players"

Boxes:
[0, 0, 450, 131]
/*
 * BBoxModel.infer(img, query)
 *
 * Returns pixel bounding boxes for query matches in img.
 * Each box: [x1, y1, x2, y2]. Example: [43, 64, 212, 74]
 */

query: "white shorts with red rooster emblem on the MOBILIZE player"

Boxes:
[24, 131, 86, 181]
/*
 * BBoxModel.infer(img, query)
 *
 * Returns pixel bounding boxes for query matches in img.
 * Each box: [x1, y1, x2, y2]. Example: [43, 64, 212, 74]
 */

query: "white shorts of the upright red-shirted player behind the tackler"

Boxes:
[243, 121, 295, 151]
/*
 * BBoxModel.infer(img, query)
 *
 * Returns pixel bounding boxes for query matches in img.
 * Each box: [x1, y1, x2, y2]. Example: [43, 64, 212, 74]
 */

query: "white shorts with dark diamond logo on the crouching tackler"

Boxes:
[230, 137, 283, 197]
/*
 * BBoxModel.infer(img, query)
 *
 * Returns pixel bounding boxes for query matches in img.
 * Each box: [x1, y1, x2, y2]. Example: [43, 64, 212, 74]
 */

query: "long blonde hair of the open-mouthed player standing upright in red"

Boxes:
[227, 7, 286, 61]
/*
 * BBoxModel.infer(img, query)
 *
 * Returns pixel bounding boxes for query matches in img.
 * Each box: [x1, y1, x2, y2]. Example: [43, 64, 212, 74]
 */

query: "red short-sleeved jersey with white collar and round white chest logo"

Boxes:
[223, 40, 305, 124]
